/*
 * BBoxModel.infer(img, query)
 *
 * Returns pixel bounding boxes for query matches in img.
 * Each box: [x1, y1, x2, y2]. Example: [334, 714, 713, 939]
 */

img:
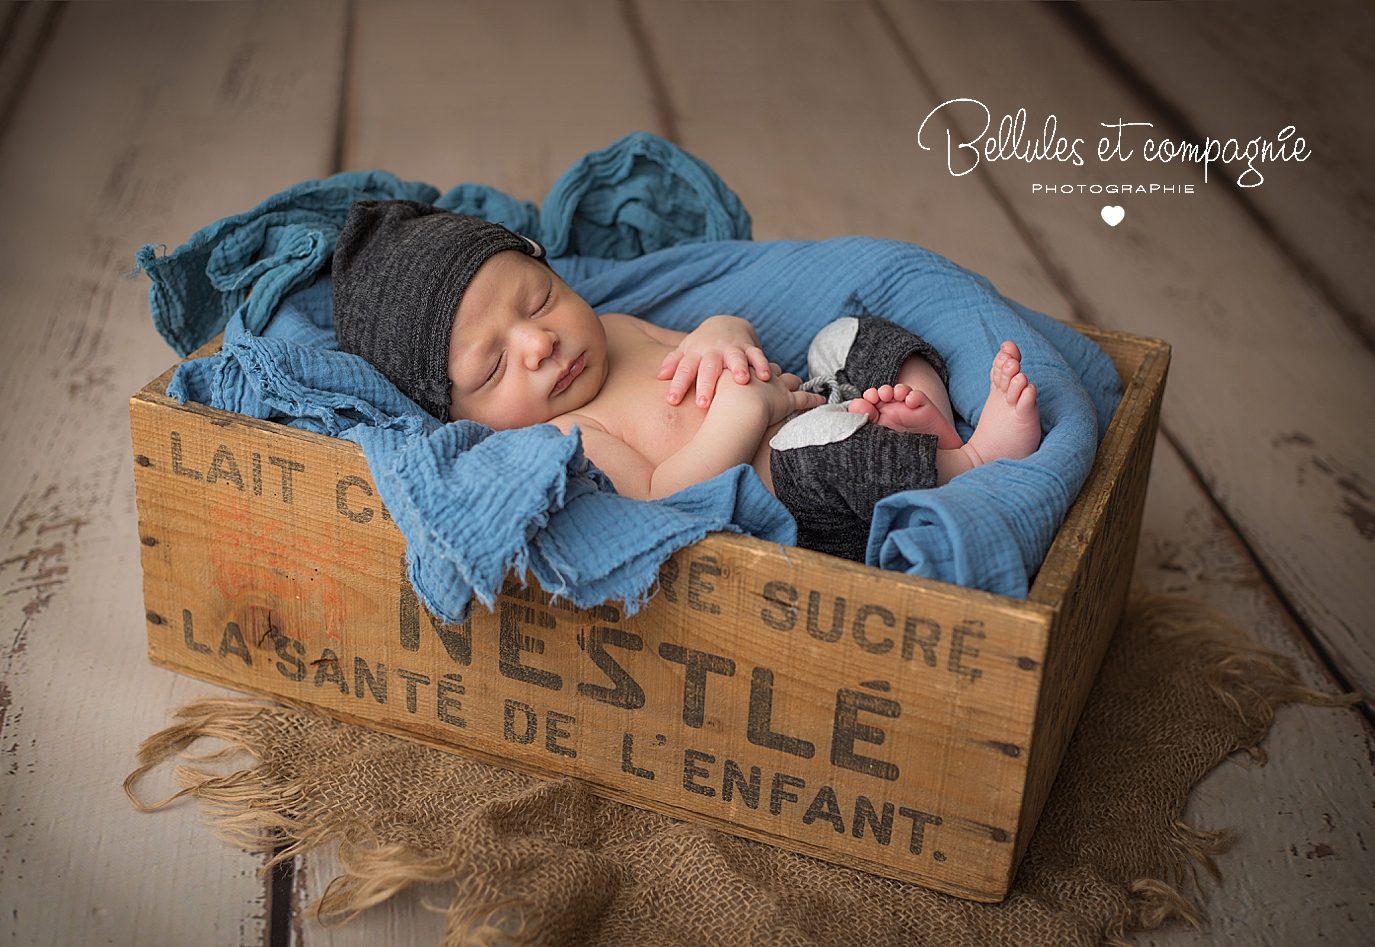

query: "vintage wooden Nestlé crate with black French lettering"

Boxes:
[129, 326, 1170, 902]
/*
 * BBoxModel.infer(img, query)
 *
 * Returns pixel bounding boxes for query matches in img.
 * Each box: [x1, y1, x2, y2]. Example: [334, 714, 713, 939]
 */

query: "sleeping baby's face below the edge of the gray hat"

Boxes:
[448, 250, 608, 430]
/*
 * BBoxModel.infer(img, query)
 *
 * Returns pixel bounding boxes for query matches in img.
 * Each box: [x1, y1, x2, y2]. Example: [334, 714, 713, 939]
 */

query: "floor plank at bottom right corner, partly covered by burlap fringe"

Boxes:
[1132, 444, 1375, 947]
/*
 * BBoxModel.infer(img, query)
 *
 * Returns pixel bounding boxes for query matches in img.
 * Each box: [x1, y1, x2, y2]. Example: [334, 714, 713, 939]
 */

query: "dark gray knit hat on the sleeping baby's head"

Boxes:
[333, 201, 545, 421]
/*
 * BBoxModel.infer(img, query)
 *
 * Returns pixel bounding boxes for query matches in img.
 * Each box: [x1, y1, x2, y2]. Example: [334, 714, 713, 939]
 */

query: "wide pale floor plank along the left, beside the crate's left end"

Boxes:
[0, 4, 338, 944]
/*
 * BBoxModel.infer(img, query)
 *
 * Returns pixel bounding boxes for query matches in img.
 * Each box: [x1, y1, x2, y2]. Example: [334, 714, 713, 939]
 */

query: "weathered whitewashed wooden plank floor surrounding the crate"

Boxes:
[0, 0, 1375, 947]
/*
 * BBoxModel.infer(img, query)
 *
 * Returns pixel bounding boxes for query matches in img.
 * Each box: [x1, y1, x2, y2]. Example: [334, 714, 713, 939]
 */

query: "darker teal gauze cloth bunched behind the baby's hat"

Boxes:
[135, 132, 749, 356]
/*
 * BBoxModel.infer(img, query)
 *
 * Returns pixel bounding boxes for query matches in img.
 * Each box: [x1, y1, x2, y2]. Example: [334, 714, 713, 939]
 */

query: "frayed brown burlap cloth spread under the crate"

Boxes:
[125, 598, 1346, 947]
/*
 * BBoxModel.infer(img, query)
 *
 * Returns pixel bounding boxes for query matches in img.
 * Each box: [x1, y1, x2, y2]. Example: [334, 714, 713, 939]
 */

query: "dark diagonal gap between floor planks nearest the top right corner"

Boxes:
[1055, 4, 1375, 353]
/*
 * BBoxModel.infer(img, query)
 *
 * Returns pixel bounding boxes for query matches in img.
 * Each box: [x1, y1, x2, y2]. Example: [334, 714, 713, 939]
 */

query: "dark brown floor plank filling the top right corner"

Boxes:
[1084, 1, 1375, 344]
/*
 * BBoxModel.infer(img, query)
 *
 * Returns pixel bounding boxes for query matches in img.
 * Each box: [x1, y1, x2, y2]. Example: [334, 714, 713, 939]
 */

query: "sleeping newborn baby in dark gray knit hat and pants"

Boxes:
[333, 201, 1041, 562]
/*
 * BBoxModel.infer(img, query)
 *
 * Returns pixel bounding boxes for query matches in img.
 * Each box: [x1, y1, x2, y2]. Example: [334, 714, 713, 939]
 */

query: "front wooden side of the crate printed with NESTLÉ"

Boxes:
[133, 384, 1028, 896]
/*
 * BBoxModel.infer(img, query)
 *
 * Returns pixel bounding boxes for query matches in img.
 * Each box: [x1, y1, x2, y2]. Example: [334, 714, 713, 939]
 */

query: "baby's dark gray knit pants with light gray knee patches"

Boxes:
[769, 316, 950, 562]
